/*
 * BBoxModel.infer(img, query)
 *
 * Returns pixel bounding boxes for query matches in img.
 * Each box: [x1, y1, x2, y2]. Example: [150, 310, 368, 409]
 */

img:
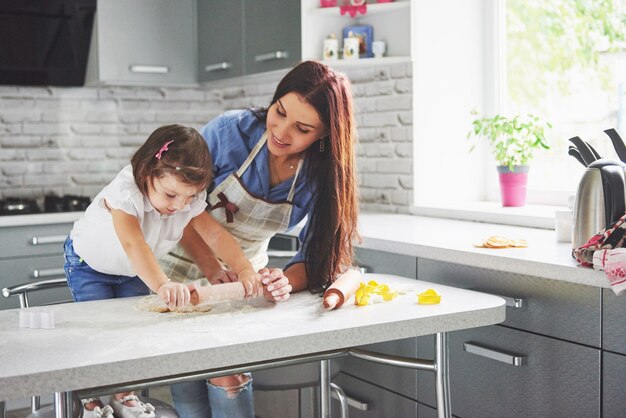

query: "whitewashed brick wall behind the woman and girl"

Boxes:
[0, 63, 413, 212]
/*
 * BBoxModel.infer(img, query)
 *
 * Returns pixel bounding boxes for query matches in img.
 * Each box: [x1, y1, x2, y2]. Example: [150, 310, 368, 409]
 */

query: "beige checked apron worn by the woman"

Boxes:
[160, 133, 302, 280]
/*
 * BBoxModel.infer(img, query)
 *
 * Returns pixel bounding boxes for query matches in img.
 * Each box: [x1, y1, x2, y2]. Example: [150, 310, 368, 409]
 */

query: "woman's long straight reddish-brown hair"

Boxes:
[258, 61, 360, 292]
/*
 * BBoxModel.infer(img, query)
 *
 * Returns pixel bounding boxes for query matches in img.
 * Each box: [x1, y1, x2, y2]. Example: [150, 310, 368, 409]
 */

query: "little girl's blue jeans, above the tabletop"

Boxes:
[63, 237, 150, 302]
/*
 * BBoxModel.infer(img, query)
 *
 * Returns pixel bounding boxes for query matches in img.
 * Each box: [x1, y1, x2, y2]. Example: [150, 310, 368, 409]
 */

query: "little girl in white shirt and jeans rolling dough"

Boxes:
[65, 125, 263, 418]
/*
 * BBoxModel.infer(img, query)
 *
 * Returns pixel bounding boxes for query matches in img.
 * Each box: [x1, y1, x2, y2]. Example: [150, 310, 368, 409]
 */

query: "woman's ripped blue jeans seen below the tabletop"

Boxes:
[171, 379, 254, 418]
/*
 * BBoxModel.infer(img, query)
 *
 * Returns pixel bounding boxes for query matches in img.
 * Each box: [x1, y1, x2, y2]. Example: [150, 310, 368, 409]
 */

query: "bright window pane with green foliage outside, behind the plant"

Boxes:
[498, 0, 626, 205]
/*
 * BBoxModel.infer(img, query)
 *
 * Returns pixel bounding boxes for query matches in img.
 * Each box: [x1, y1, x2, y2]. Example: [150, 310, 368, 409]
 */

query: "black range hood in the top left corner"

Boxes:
[0, 0, 96, 86]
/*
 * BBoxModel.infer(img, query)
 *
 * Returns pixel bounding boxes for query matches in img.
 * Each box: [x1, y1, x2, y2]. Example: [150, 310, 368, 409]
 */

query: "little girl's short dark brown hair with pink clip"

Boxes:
[130, 125, 213, 194]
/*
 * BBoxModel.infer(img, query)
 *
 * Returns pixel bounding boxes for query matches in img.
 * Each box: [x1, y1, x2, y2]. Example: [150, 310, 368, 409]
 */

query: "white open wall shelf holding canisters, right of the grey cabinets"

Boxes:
[302, 0, 413, 66]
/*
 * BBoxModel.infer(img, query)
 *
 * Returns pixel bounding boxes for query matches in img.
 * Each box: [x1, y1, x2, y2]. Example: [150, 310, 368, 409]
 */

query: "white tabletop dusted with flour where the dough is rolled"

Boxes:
[0, 274, 505, 400]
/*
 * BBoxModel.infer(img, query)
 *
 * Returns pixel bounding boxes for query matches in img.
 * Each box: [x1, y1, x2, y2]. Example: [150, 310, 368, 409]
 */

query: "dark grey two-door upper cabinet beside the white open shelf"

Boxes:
[198, 0, 302, 81]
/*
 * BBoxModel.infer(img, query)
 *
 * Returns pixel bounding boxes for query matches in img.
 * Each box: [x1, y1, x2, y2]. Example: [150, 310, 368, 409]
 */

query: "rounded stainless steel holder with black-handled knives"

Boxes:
[569, 129, 626, 249]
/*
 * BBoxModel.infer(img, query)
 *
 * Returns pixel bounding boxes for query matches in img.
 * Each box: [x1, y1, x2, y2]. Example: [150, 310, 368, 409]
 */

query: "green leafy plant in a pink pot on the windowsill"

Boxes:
[467, 112, 552, 206]
